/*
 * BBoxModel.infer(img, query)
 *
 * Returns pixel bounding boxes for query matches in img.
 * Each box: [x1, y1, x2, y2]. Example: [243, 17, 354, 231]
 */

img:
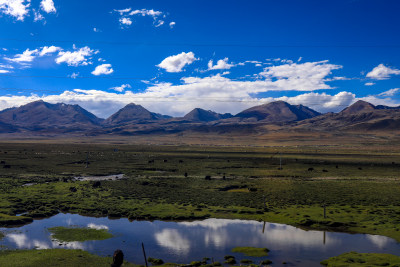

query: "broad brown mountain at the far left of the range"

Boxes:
[0, 100, 102, 131]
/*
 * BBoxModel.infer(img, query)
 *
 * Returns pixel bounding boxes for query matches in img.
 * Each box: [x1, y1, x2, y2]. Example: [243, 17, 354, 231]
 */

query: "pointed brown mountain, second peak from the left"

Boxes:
[103, 103, 170, 125]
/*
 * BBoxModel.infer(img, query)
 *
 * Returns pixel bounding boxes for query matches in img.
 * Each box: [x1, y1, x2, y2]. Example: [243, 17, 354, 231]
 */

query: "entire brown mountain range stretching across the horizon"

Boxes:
[0, 100, 400, 135]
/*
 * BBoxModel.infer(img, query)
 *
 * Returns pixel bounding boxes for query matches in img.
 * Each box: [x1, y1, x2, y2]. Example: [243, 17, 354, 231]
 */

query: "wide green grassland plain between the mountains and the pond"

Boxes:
[0, 142, 400, 262]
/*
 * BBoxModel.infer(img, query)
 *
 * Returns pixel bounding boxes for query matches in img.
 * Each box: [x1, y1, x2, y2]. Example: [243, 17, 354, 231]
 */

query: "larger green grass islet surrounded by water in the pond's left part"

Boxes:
[48, 226, 113, 242]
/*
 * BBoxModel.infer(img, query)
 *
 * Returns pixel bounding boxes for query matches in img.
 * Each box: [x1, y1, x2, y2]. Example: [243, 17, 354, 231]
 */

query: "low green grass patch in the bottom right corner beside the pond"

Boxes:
[321, 252, 400, 267]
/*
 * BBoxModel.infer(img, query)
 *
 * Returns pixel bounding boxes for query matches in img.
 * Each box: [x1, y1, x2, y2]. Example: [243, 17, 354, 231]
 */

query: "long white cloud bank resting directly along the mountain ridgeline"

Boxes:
[0, 88, 400, 118]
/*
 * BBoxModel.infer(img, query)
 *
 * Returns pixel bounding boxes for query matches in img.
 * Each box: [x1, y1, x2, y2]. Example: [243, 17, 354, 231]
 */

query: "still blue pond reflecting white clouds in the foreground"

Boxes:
[0, 213, 400, 266]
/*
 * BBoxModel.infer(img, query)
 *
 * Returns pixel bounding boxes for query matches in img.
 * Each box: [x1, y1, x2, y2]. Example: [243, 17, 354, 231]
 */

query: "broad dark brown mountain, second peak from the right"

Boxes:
[235, 101, 320, 123]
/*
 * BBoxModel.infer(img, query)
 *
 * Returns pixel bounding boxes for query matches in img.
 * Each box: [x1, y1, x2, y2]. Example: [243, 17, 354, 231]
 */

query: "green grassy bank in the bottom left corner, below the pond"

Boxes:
[0, 249, 138, 267]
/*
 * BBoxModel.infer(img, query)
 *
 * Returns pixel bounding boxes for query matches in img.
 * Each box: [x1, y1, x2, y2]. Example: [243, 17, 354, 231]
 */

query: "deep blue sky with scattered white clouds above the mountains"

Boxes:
[0, 0, 400, 118]
